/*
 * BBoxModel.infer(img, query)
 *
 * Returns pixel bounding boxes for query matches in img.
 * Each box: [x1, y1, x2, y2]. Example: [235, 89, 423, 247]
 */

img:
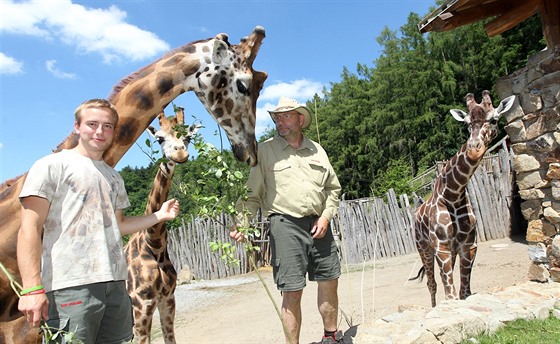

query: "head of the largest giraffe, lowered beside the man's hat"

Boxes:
[189, 26, 267, 166]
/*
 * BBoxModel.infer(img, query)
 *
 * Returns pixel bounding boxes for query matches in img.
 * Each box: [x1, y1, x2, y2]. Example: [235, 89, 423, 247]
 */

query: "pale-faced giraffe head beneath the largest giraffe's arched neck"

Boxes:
[146, 107, 200, 164]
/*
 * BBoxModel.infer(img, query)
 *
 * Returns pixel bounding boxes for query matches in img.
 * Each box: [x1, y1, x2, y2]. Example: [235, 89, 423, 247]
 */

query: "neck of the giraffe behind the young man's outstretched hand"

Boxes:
[141, 162, 175, 254]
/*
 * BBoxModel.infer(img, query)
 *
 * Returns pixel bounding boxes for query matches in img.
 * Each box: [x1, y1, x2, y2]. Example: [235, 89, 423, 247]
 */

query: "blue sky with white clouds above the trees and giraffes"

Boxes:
[0, 0, 435, 182]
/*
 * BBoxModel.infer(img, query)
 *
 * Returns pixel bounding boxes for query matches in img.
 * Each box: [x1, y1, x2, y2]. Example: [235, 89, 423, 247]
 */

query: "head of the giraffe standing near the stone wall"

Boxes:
[450, 91, 515, 160]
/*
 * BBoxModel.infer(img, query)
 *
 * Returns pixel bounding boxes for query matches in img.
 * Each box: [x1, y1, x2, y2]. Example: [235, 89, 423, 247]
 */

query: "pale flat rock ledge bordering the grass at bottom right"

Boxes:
[352, 282, 560, 344]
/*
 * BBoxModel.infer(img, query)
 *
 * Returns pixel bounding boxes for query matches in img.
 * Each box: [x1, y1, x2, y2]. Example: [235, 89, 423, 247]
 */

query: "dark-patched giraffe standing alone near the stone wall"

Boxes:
[413, 91, 515, 307]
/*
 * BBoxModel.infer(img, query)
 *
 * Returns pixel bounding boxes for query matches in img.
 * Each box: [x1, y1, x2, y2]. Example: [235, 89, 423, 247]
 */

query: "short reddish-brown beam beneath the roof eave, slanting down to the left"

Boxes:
[484, 0, 544, 37]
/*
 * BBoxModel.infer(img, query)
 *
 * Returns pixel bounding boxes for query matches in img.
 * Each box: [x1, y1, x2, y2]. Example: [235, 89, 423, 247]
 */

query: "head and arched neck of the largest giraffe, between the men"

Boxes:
[55, 26, 267, 166]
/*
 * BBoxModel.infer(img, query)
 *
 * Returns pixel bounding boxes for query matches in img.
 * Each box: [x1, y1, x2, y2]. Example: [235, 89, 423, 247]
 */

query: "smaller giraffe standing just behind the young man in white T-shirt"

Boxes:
[124, 108, 198, 344]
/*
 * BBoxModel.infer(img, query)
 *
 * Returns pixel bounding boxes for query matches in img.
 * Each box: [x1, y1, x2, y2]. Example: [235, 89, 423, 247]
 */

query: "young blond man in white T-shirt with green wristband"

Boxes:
[17, 99, 179, 344]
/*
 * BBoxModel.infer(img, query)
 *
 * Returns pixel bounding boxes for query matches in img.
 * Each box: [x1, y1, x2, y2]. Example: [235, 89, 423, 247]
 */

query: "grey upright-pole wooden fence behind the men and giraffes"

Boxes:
[168, 150, 523, 279]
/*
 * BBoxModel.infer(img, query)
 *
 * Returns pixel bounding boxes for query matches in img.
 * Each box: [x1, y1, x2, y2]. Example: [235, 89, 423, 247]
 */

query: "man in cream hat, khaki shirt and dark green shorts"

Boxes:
[230, 97, 342, 344]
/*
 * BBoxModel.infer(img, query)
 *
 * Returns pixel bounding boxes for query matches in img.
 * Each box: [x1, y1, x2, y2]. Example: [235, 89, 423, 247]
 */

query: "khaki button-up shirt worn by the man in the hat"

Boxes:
[237, 135, 341, 225]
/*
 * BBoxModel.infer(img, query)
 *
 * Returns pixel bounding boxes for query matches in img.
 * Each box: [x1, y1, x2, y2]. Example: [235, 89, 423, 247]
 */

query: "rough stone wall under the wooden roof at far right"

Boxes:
[496, 46, 560, 282]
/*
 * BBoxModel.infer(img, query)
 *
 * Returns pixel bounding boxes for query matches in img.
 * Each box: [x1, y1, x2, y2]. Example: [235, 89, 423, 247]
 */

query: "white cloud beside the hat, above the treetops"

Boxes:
[255, 79, 325, 138]
